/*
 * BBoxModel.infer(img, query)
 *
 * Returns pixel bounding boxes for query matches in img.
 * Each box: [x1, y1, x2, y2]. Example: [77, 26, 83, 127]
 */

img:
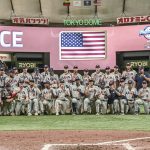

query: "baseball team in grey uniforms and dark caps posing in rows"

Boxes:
[0, 63, 150, 116]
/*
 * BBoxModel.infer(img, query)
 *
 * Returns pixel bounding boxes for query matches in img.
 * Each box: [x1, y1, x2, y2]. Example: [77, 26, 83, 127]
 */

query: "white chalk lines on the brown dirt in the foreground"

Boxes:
[41, 137, 150, 150]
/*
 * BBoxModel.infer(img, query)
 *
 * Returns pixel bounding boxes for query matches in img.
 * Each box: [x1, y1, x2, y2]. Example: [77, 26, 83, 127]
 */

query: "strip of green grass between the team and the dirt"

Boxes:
[0, 115, 150, 131]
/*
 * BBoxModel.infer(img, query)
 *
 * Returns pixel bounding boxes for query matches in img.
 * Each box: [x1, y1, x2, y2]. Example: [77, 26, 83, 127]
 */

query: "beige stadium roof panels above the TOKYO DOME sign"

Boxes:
[0, 0, 150, 25]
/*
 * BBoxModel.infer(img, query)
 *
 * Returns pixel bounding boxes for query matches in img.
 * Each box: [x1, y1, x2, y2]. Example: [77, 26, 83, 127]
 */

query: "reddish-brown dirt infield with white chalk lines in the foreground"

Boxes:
[0, 130, 150, 150]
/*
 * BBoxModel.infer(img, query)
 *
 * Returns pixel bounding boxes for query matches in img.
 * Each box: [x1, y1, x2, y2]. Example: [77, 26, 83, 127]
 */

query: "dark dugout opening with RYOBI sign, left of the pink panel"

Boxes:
[0, 52, 50, 71]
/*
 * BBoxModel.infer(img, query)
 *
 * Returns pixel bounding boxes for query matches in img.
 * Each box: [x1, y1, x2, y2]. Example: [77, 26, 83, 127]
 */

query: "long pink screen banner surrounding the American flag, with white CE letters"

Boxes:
[0, 24, 150, 70]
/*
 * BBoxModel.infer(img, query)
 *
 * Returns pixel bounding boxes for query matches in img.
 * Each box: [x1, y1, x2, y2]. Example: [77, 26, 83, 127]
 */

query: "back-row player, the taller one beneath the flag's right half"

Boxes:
[91, 65, 104, 86]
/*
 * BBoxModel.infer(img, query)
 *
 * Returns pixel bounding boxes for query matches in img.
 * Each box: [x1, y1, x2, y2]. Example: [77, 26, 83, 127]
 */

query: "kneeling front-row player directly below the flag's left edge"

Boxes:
[53, 81, 70, 116]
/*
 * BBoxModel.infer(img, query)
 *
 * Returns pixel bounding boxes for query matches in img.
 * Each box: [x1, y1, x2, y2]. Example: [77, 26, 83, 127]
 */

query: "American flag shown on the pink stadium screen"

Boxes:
[59, 31, 106, 60]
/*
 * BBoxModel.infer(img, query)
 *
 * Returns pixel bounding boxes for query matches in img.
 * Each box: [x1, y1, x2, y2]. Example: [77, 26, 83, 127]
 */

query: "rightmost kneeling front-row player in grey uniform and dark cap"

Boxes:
[135, 80, 150, 114]
